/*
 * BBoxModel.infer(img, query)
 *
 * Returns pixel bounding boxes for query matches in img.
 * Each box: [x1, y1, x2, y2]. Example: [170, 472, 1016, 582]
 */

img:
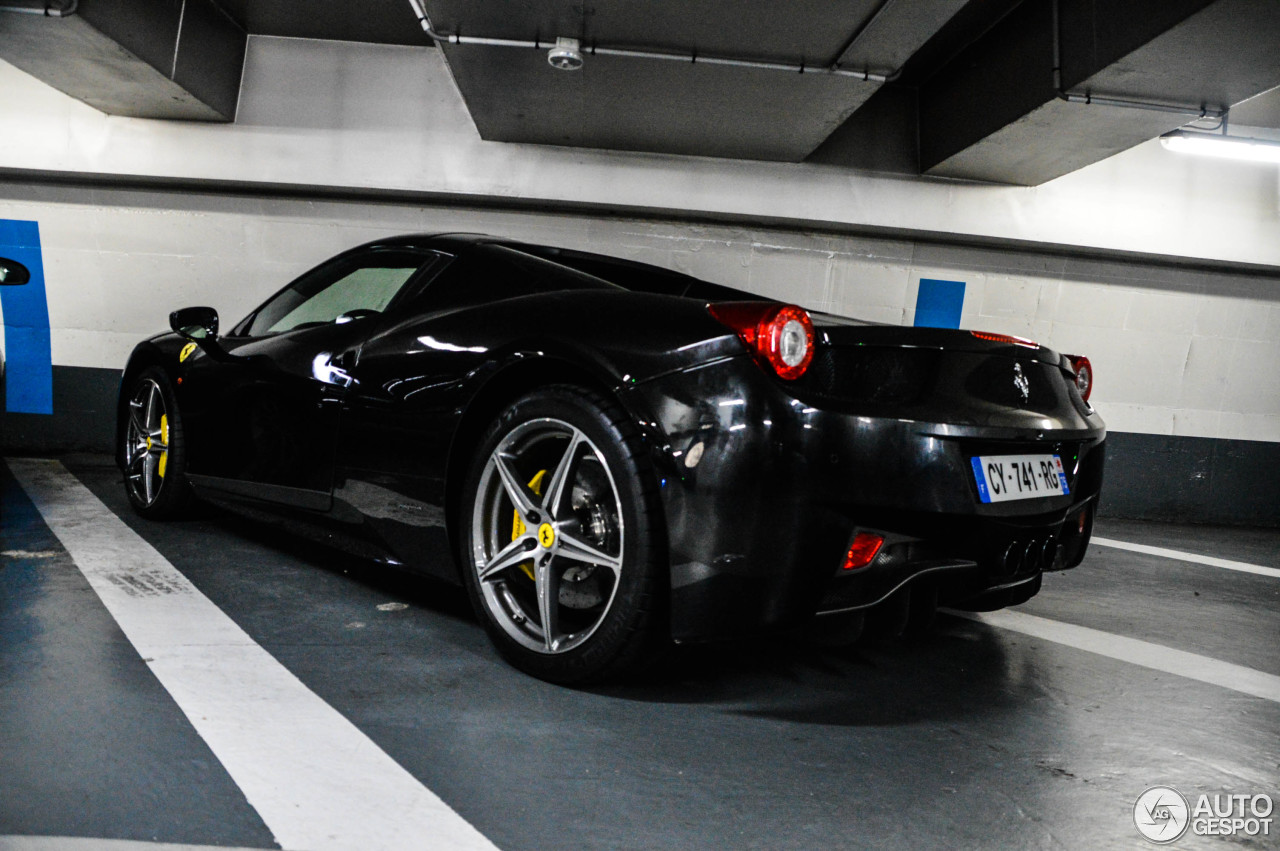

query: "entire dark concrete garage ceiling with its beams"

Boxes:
[0, 0, 1280, 184]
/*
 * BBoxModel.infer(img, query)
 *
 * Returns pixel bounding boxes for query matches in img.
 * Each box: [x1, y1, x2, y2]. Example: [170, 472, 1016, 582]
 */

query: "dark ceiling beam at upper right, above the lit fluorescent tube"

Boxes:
[919, 0, 1280, 186]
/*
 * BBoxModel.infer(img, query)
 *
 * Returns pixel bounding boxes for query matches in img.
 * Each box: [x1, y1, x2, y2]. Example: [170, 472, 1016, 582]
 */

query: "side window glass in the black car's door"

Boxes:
[244, 251, 435, 337]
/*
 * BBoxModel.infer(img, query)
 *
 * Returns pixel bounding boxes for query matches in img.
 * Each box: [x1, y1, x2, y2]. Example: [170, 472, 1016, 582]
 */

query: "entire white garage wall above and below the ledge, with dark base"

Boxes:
[0, 38, 1280, 523]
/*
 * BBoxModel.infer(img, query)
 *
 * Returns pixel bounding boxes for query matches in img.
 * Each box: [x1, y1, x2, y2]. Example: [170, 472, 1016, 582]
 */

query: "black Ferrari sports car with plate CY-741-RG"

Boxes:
[118, 234, 1106, 682]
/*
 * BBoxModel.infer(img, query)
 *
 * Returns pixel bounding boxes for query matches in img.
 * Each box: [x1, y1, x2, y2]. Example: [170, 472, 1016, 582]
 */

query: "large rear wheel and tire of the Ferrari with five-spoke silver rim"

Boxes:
[456, 385, 667, 683]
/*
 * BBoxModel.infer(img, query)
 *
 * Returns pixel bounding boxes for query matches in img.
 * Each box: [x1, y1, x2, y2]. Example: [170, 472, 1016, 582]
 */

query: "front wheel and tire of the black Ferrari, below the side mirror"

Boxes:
[119, 366, 192, 520]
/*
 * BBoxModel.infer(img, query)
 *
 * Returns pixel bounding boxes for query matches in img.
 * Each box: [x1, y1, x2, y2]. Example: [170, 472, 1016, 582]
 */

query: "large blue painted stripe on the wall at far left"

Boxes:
[0, 219, 54, 413]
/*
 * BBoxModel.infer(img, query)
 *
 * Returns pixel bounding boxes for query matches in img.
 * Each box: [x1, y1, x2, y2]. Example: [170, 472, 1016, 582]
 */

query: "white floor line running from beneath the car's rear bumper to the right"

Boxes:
[948, 609, 1280, 703]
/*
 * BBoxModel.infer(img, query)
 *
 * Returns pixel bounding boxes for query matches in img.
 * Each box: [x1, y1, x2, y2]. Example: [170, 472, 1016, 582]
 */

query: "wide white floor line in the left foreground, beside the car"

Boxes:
[6, 459, 495, 851]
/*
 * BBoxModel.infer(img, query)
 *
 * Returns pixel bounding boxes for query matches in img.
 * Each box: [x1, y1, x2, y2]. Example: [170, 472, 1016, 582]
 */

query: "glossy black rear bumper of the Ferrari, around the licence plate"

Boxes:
[630, 357, 1106, 640]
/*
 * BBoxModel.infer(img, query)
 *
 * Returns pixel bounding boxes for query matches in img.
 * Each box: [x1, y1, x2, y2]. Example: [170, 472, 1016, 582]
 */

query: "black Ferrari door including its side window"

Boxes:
[183, 248, 436, 512]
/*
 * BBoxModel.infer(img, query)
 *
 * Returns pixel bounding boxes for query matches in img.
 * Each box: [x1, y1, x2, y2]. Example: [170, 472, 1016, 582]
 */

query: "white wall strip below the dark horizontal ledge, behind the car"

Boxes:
[0, 183, 1280, 441]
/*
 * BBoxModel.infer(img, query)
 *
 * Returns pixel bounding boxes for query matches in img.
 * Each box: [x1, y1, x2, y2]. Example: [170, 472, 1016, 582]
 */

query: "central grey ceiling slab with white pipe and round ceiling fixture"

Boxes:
[426, 0, 964, 161]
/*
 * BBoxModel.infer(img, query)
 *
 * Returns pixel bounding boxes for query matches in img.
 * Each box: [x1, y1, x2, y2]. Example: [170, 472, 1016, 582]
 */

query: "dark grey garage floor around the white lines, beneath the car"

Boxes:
[0, 459, 1280, 851]
